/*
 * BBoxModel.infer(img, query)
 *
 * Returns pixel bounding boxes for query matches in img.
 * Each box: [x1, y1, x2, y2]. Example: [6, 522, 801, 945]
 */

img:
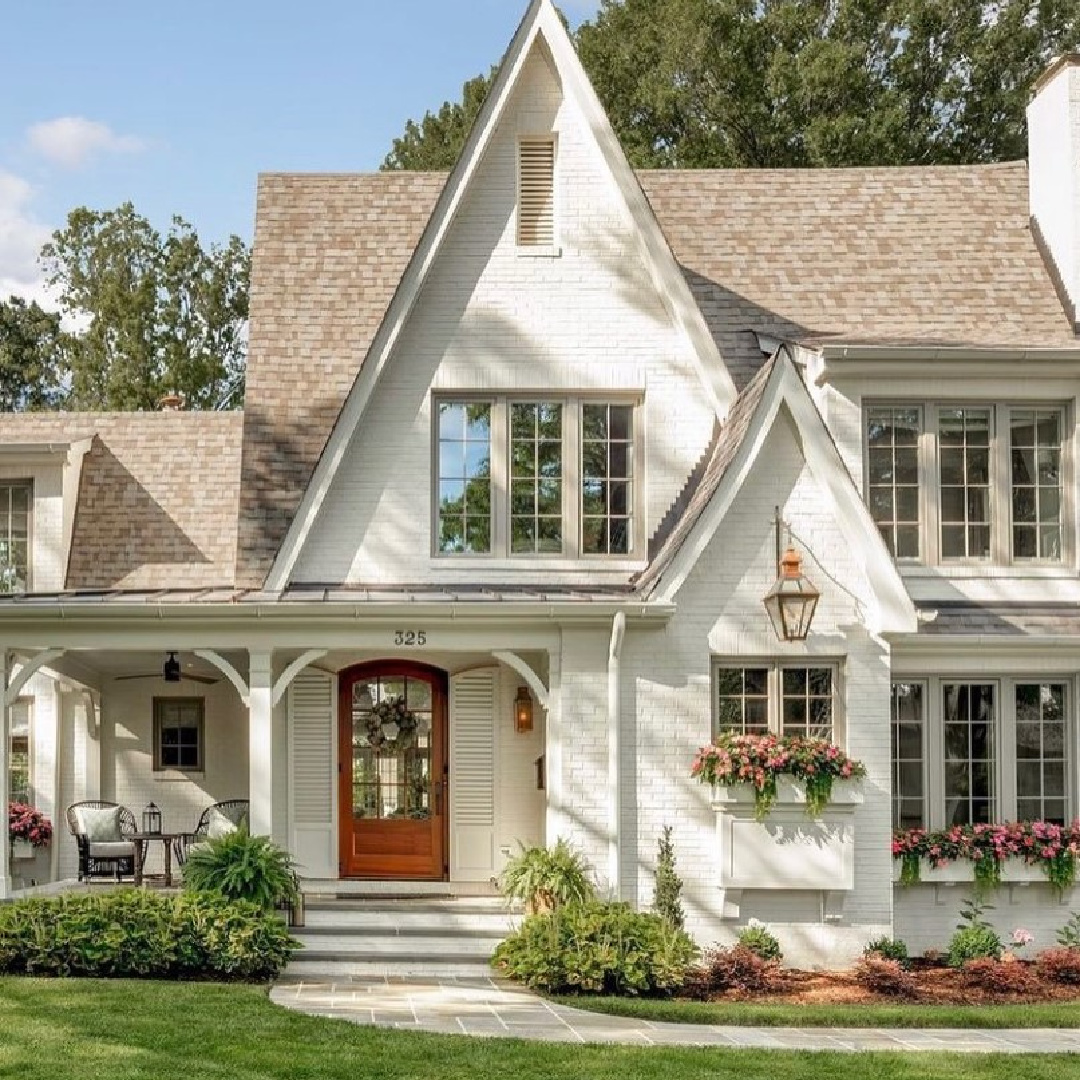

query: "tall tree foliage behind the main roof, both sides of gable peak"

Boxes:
[384, 0, 1080, 170]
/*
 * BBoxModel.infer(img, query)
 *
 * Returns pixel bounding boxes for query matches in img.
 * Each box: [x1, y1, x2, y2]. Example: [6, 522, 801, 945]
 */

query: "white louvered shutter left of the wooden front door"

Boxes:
[288, 667, 337, 877]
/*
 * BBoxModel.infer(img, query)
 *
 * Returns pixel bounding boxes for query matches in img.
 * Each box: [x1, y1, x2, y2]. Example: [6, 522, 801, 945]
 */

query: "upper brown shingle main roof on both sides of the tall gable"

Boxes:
[237, 162, 1077, 586]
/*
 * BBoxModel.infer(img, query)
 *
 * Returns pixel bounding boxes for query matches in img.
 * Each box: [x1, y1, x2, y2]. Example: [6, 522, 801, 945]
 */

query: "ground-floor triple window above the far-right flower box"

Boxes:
[892, 675, 1075, 828]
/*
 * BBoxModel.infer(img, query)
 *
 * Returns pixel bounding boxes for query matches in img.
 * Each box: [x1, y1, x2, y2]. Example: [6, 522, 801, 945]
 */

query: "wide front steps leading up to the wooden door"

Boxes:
[285, 881, 522, 978]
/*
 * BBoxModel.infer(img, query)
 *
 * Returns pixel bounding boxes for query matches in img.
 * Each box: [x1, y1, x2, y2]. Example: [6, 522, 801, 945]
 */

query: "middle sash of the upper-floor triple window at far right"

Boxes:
[937, 408, 990, 558]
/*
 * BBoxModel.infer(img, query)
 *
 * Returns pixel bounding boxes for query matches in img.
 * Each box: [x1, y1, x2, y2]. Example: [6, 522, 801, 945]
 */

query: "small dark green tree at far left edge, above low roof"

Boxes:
[0, 296, 68, 413]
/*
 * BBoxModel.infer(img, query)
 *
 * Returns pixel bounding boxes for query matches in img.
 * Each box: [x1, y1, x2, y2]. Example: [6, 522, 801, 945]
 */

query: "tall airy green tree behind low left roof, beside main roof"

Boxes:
[41, 203, 251, 409]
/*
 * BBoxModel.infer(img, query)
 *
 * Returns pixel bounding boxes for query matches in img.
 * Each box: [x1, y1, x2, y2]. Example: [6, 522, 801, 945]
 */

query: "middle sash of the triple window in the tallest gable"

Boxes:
[510, 402, 563, 555]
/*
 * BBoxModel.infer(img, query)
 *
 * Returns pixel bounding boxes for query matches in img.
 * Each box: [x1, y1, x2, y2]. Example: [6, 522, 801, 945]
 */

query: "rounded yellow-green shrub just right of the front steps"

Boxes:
[492, 901, 697, 995]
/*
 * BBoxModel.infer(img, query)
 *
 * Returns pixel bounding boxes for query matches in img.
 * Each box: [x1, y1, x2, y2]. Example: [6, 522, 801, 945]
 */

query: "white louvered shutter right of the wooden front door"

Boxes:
[450, 667, 499, 880]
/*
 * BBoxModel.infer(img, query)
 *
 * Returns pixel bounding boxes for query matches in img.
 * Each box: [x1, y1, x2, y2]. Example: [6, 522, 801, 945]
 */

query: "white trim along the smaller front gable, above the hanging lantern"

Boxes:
[657, 348, 917, 634]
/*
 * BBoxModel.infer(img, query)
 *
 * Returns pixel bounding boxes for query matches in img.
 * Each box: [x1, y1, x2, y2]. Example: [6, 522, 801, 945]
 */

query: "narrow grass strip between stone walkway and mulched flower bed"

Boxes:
[554, 997, 1080, 1028]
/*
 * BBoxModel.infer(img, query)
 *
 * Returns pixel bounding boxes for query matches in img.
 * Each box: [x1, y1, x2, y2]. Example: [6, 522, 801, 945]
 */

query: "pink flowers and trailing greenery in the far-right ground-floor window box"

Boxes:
[892, 821, 1080, 890]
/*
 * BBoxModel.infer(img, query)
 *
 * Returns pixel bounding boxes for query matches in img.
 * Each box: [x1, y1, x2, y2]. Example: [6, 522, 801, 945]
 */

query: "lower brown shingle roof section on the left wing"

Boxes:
[0, 413, 243, 589]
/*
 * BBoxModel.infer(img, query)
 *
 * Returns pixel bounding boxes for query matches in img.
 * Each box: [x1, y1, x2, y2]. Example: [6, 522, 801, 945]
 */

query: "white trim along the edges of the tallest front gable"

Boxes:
[266, 0, 737, 592]
